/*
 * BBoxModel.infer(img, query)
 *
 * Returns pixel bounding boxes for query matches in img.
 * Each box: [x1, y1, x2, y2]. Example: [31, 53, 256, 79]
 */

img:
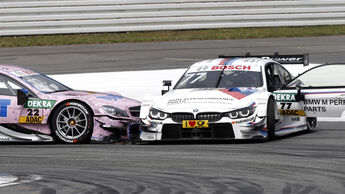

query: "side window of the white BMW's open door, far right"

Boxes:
[286, 64, 345, 88]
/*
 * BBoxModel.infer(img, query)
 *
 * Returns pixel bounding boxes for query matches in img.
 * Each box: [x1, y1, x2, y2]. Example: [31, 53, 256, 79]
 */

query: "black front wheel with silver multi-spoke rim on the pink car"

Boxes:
[50, 101, 93, 144]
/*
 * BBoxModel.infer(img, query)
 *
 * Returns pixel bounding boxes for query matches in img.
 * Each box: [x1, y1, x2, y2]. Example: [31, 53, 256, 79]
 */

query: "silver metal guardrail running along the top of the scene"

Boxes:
[0, 0, 345, 36]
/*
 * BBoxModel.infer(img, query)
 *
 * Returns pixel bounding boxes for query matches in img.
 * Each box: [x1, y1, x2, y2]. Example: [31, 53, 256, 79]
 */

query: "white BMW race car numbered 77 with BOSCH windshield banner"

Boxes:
[140, 54, 342, 141]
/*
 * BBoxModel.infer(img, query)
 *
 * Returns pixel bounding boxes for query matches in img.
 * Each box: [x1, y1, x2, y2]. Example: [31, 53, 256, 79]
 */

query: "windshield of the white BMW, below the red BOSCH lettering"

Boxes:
[175, 70, 263, 89]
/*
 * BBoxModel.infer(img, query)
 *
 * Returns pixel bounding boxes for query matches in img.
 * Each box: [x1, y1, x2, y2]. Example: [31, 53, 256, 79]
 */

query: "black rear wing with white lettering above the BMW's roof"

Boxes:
[218, 52, 309, 66]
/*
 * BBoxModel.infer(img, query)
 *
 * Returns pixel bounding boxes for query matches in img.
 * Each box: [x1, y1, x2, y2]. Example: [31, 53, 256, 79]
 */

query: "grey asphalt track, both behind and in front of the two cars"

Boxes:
[0, 36, 345, 194]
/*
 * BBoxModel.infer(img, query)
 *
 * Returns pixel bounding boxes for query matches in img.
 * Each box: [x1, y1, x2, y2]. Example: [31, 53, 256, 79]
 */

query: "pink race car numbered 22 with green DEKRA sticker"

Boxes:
[0, 65, 140, 143]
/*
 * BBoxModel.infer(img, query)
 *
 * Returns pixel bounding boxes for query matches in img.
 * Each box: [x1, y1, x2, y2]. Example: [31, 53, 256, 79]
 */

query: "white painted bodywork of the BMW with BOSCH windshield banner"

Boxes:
[140, 58, 307, 141]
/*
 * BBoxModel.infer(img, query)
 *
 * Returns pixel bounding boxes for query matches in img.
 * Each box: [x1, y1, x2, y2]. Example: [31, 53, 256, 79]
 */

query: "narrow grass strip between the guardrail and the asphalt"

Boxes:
[0, 25, 345, 47]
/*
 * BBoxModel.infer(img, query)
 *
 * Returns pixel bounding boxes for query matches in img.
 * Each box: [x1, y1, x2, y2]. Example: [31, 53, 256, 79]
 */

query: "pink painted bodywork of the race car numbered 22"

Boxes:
[0, 65, 140, 140]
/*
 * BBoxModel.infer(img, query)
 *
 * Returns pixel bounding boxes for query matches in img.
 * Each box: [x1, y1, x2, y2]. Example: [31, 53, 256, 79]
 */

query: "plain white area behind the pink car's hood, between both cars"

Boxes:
[50, 69, 186, 101]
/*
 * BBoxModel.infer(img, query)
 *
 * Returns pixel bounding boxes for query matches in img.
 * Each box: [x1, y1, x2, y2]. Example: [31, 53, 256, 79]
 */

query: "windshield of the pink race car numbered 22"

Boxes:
[20, 73, 72, 93]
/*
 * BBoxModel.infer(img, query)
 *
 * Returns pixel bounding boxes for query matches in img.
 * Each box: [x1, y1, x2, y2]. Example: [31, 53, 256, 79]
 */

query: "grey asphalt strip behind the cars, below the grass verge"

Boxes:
[0, 36, 345, 74]
